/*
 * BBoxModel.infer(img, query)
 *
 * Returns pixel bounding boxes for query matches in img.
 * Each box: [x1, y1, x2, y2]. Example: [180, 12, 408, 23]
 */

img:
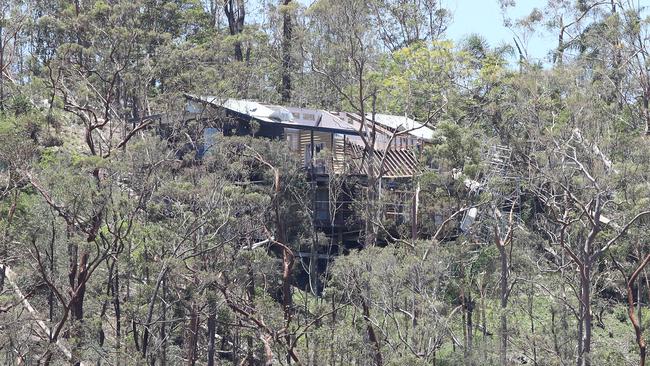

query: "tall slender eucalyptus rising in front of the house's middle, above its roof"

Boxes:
[308, 0, 382, 247]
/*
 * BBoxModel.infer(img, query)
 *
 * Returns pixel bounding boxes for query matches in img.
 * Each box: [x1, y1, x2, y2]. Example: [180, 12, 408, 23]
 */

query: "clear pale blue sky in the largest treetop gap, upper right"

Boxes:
[441, 0, 552, 62]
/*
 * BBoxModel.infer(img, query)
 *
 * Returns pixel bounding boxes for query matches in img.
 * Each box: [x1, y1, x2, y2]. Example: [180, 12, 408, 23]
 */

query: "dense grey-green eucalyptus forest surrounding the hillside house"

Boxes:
[0, 0, 650, 365]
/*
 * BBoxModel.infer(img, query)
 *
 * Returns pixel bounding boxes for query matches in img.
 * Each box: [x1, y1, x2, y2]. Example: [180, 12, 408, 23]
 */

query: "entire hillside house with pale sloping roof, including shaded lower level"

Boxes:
[184, 94, 433, 250]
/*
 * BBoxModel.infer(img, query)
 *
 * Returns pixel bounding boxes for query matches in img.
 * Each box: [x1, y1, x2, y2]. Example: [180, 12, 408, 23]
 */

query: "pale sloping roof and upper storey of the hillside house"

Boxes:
[185, 94, 433, 178]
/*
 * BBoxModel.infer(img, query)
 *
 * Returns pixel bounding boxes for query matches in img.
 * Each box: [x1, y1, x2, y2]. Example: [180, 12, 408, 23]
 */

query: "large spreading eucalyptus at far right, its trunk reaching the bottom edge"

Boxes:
[498, 68, 648, 365]
